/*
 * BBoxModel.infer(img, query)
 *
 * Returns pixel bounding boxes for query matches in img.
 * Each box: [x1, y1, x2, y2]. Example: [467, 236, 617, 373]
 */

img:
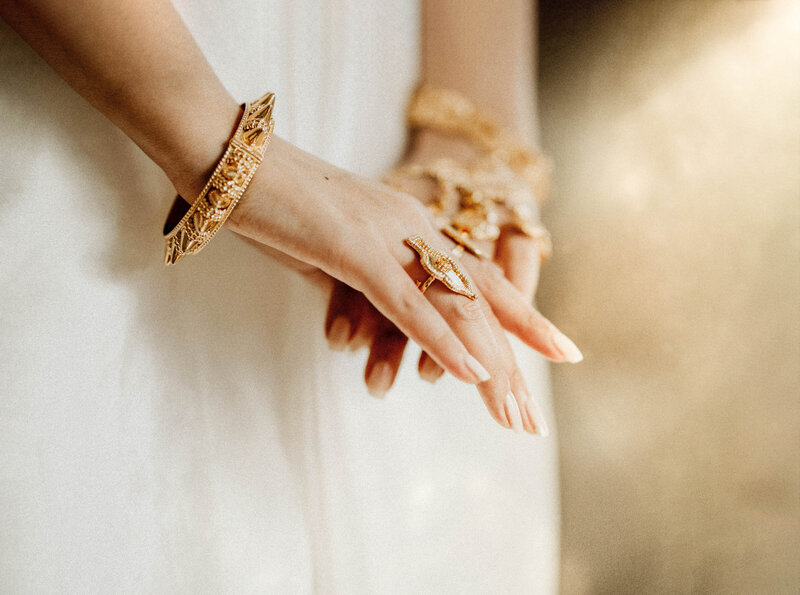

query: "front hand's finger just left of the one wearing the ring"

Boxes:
[361, 257, 490, 384]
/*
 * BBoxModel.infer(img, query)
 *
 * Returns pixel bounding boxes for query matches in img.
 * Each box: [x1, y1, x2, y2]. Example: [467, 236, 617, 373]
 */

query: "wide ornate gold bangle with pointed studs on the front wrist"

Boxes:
[164, 93, 275, 265]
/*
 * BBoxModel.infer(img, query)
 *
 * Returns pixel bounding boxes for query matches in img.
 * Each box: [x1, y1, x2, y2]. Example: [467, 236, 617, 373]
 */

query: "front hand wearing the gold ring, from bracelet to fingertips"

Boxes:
[223, 137, 576, 431]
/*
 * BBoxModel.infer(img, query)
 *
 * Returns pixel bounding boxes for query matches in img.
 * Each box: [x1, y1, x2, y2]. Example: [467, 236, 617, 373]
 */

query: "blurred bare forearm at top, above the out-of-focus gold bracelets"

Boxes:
[422, 0, 538, 146]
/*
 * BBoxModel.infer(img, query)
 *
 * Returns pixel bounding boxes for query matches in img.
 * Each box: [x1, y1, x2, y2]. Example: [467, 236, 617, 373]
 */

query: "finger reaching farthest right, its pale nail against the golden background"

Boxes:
[469, 259, 583, 364]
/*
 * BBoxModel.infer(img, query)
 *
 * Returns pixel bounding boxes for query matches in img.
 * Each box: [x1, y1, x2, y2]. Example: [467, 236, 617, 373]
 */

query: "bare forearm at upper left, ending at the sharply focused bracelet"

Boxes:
[0, 0, 239, 195]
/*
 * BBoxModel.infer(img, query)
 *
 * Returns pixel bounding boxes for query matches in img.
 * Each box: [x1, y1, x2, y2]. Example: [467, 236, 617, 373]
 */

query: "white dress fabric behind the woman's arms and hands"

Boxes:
[0, 0, 559, 594]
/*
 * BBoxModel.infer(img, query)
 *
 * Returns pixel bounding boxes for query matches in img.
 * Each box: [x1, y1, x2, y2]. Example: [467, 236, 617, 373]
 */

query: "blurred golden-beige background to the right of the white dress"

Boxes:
[539, 0, 800, 594]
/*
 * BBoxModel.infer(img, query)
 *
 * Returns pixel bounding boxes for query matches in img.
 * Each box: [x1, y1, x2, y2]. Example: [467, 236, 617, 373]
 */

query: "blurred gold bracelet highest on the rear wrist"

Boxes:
[407, 85, 552, 203]
